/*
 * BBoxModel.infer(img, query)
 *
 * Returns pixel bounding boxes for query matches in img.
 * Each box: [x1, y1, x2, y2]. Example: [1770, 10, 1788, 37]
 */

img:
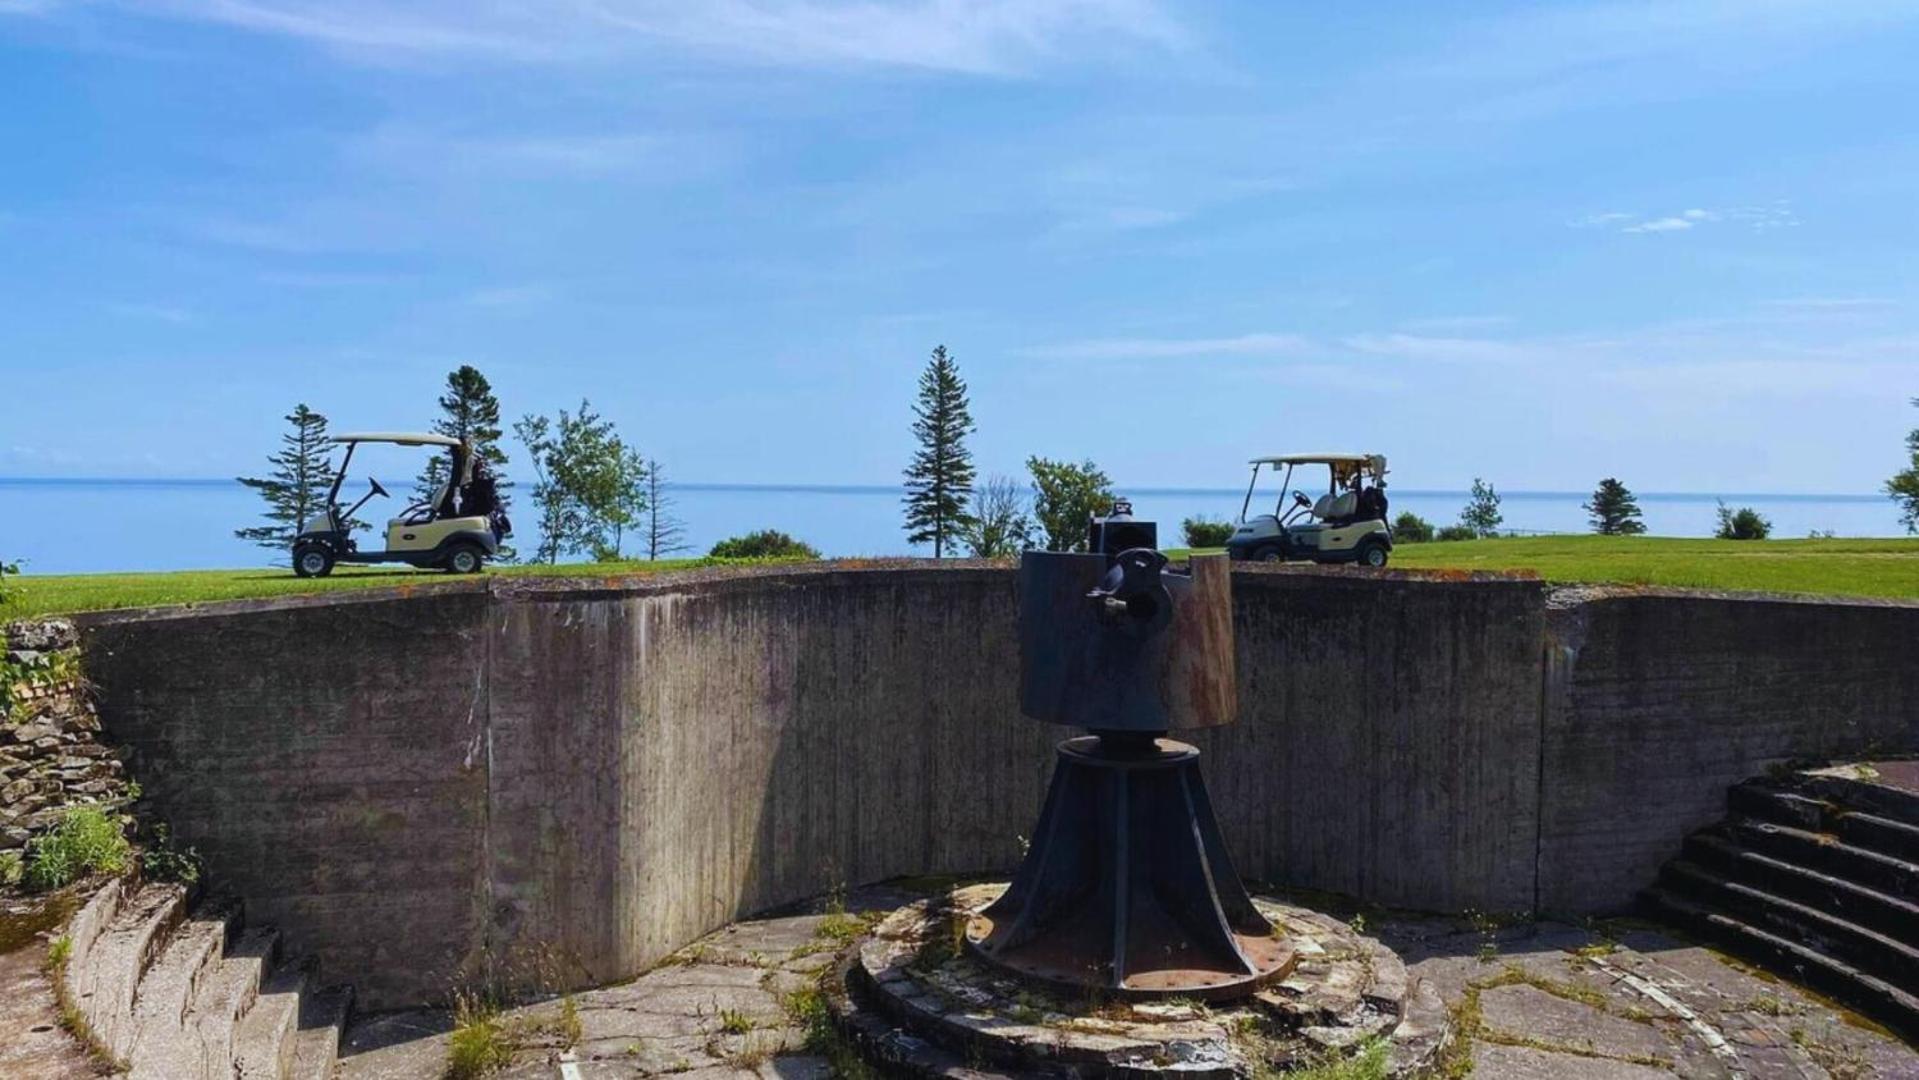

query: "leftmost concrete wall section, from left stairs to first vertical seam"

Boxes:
[86, 589, 489, 1003]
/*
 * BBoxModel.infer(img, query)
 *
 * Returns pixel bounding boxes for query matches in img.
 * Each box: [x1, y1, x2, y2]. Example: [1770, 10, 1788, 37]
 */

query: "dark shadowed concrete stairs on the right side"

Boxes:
[1643, 773, 1919, 1038]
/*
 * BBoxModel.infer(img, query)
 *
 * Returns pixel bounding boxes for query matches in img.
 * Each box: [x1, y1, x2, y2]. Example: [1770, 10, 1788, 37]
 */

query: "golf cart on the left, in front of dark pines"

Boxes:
[294, 432, 512, 577]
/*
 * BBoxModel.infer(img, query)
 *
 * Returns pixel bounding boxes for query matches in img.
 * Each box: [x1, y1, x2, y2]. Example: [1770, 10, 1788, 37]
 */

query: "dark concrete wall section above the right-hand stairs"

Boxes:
[1539, 595, 1919, 911]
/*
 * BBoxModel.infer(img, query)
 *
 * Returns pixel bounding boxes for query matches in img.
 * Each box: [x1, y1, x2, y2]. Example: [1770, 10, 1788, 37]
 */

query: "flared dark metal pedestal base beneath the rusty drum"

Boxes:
[967, 735, 1293, 999]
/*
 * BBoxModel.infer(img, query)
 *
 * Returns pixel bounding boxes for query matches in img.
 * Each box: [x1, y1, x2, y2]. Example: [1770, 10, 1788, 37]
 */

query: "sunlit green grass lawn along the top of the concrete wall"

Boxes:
[0, 537, 1919, 620]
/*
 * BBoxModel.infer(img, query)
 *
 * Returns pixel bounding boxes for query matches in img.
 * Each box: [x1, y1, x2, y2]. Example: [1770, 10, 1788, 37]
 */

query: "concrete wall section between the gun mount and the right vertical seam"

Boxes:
[1196, 572, 1545, 911]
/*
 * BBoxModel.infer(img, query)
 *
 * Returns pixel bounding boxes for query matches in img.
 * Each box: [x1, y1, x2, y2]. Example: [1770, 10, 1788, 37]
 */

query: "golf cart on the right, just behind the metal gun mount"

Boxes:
[1226, 455, 1393, 566]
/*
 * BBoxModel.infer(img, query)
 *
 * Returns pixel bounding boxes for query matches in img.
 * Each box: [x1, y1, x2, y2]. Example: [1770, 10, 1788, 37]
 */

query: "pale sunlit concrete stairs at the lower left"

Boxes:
[67, 882, 353, 1080]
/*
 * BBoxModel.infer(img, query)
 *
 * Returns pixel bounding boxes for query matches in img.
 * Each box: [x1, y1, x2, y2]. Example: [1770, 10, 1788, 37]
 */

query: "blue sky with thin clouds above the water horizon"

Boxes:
[0, 0, 1919, 491]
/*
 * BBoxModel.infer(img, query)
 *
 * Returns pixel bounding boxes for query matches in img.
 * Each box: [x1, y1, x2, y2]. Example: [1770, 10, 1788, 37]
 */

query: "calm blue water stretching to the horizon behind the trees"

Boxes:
[0, 478, 1902, 574]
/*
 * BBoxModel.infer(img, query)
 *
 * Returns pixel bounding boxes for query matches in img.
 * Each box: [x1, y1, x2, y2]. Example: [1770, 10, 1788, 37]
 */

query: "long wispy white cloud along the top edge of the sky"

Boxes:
[56, 0, 1186, 75]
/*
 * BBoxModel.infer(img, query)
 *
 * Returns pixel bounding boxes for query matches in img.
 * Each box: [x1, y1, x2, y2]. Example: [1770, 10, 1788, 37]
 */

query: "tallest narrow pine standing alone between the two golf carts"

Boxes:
[906, 345, 973, 558]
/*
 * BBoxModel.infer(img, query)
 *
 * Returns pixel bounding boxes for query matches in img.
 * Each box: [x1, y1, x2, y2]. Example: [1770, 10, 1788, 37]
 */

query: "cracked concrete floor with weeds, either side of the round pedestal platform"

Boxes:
[340, 886, 1919, 1080]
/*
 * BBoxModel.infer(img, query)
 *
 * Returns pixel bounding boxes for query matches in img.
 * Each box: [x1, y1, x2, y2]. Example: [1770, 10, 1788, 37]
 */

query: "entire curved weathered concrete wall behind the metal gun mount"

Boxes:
[86, 564, 1919, 1007]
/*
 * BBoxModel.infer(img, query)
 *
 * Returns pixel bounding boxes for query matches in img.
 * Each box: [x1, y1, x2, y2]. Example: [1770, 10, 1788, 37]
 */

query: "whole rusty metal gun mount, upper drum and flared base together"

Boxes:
[965, 528, 1293, 999]
